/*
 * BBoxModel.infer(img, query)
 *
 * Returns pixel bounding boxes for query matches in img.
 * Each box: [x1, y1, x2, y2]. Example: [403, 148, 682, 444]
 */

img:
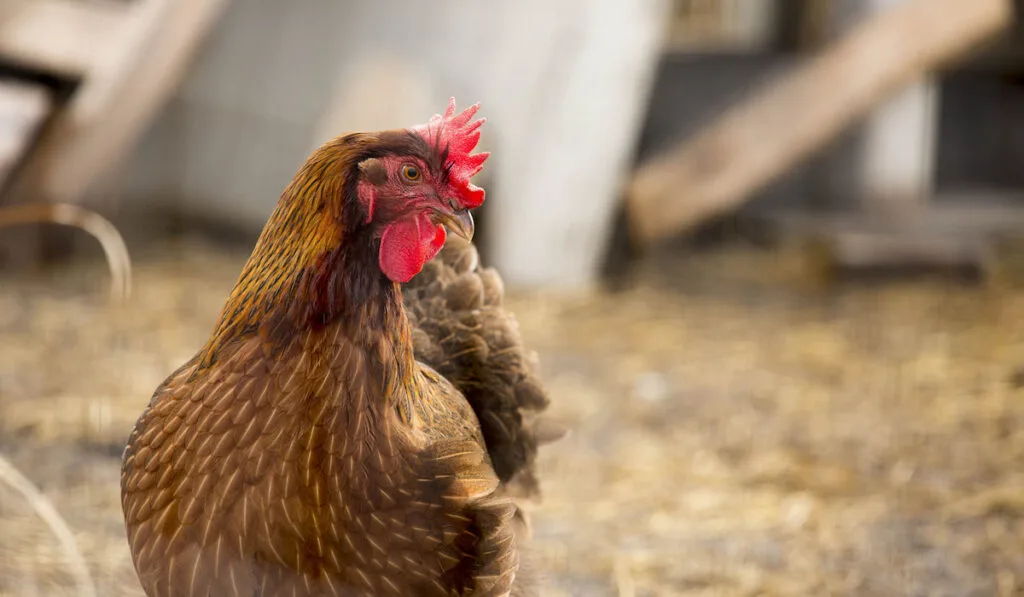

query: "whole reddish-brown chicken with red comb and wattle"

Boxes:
[121, 99, 557, 597]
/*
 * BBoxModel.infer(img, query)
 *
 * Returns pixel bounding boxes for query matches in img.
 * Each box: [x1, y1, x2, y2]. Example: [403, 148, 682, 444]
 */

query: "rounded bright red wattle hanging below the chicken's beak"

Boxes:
[379, 213, 446, 284]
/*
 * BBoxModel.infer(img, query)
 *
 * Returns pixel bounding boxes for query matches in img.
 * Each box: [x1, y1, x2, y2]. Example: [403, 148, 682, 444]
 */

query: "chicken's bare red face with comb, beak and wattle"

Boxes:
[357, 98, 488, 283]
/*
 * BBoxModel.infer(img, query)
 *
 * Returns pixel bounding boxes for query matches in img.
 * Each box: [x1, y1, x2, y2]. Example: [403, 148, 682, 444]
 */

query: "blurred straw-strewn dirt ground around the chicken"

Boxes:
[0, 234, 1024, 597]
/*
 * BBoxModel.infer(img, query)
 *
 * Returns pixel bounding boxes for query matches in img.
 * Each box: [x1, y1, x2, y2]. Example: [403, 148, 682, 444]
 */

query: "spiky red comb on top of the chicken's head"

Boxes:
[413, 97, 490, 208]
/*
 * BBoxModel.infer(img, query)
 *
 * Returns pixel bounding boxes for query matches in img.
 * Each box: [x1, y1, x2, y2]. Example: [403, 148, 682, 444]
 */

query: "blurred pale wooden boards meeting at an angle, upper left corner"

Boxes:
[0, 0, 226, 203]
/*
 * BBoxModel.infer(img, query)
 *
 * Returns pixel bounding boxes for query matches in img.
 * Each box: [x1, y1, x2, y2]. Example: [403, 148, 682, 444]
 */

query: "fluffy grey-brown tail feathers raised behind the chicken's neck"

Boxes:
[402, 239, 561, 496]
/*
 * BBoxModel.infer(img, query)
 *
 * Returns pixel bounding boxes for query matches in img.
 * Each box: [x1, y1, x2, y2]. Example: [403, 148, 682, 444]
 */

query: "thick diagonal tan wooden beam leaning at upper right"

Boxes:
[627, 0, 1012, 245]
